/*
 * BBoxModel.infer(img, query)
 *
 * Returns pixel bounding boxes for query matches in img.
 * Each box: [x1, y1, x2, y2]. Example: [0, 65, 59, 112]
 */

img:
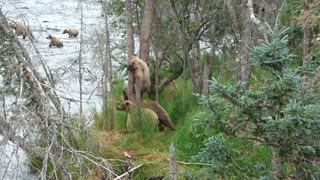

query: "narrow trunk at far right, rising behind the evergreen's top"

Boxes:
[303, 0, 312, 66]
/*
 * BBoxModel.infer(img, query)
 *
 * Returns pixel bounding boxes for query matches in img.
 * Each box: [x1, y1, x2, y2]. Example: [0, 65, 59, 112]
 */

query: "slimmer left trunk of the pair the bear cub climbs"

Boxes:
[125, 0, 135, 102]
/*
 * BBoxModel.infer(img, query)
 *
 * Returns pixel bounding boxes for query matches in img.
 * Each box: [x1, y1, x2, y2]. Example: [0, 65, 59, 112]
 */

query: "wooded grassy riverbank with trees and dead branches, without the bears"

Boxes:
[0, 0, 320, 179]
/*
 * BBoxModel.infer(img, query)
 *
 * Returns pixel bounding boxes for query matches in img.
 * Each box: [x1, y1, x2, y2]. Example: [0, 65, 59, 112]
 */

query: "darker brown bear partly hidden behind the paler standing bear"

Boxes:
[122, 90, 176, 131]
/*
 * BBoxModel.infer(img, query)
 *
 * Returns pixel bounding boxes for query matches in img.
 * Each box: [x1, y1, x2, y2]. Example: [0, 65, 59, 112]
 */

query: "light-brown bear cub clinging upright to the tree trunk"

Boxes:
[128, 56, 151, 97]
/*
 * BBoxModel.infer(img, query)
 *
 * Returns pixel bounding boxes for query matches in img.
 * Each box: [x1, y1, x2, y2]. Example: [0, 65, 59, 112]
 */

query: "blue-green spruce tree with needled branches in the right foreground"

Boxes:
[194, 28, 320, 179]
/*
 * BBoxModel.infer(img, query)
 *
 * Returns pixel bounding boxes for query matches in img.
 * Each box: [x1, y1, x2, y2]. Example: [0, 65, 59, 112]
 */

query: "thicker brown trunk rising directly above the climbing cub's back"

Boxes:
[139, 0, 155, 63]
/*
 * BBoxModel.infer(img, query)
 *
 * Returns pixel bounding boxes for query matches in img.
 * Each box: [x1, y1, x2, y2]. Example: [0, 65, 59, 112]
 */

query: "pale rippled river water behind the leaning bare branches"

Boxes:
[0, 0, 120, 179]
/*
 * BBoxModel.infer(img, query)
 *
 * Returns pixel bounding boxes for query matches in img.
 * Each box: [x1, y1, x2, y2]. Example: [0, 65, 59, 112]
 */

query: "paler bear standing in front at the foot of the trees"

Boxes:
[117, 100, 159, 131]
